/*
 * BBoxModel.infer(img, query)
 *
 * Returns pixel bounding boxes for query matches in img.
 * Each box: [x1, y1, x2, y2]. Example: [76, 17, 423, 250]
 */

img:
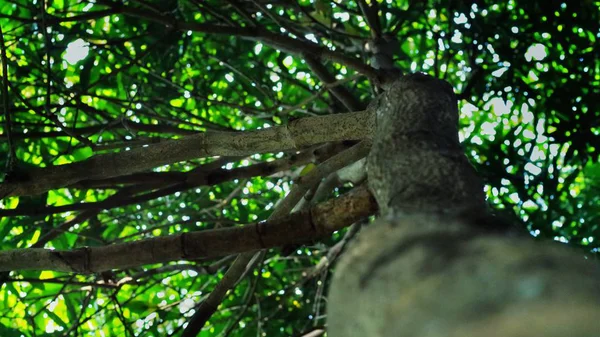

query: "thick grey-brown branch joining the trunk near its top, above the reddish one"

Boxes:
[0, 111, 374, 197]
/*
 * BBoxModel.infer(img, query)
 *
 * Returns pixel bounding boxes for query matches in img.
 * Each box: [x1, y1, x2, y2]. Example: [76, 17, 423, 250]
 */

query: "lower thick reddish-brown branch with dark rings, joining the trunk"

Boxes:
[0, 186, 377, 273]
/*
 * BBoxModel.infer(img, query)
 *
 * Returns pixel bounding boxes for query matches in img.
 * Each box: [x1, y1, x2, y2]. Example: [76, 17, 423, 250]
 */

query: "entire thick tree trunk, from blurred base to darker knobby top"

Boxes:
[328, 74, 600, 337]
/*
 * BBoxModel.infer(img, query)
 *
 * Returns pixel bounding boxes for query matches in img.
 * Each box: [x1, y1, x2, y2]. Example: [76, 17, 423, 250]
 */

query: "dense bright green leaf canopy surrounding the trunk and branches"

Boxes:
[0, 0, 600, 336]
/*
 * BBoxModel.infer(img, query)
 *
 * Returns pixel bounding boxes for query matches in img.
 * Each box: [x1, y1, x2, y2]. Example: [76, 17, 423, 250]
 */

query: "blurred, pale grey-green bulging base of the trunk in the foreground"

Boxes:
[328, 215, 600, 337]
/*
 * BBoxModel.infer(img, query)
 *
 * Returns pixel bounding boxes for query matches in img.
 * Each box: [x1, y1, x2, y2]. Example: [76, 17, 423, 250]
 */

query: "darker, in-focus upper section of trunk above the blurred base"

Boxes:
[367, 74, 484, 213]
